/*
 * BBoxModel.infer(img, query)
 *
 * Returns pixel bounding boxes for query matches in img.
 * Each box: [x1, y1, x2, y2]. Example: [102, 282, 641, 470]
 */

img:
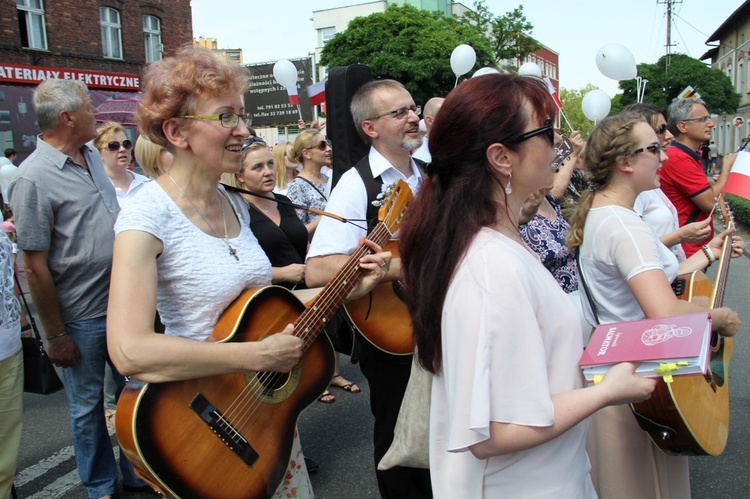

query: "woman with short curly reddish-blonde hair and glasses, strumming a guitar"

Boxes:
[107, 47, 390, 497]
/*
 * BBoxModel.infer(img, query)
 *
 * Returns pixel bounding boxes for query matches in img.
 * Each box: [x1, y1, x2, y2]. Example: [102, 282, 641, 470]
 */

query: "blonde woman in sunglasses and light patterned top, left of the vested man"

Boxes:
[286, 129, 332, 237]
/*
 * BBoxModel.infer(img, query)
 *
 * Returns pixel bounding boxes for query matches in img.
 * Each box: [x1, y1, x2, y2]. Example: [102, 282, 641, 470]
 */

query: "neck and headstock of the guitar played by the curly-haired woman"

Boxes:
[294, 223, 391, 350]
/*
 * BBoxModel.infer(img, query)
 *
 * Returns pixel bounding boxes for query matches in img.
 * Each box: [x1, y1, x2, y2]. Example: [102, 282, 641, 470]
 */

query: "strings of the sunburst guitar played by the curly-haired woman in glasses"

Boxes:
[222, 223, 391, 429]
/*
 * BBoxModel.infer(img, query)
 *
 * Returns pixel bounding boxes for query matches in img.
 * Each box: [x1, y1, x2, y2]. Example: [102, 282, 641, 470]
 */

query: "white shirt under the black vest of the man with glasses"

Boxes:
[307, 147, 422, 259]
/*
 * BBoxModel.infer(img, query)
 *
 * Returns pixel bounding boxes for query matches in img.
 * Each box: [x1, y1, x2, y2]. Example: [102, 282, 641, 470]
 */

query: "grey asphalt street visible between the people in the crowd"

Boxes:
[10, 252, 750, 499]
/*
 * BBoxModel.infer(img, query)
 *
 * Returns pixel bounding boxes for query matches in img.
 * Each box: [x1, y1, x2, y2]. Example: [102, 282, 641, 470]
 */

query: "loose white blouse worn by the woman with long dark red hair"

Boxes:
[430, 228, 596, 499]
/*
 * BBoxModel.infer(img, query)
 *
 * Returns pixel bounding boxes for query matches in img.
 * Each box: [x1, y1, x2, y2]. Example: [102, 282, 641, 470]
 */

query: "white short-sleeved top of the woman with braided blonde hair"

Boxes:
[578, 206, 679, 324]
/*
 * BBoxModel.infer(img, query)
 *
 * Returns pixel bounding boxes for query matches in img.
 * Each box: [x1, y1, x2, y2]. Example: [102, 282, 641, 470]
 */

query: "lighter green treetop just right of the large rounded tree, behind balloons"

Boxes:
[459, 0, 542, 72]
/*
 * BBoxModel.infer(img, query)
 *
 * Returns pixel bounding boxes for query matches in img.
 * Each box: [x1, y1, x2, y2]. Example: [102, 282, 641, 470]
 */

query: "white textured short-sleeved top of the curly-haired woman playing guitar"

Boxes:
[115, 182, 271, 340]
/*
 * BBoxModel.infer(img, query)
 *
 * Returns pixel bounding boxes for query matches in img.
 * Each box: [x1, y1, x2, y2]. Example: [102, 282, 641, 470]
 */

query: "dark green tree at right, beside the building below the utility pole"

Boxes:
[620, 54, 741, 114]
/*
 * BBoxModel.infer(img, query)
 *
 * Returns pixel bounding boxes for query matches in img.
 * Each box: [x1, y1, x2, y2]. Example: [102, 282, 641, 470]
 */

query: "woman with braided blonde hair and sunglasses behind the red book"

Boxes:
[568, 114, 744, 498]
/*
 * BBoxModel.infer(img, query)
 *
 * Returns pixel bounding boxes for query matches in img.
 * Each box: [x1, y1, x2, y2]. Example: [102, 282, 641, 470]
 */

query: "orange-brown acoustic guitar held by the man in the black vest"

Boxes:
[343, 136, 573, 355]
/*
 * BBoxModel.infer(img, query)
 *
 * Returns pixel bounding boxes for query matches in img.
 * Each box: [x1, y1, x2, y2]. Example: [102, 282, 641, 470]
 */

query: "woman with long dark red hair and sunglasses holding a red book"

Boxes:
[400, 75, 655, 498]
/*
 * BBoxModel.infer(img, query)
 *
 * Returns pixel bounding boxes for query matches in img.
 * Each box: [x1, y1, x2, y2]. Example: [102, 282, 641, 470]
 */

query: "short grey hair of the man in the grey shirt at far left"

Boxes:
[34, 78, 89, 132]
